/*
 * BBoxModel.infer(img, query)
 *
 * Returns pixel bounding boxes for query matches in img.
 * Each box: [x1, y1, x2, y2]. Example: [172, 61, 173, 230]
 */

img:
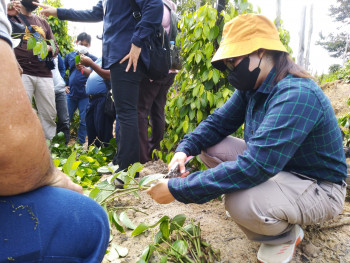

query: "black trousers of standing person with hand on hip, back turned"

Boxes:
[110, 60, 144, 171]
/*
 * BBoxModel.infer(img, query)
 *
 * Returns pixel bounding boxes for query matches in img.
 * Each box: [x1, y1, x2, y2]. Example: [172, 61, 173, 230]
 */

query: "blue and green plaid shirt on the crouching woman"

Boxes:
[168, 69, 347, 203]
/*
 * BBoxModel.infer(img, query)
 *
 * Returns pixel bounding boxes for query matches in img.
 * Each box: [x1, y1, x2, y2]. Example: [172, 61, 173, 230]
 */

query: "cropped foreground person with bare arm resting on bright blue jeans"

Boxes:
[0, 0, 110, 263]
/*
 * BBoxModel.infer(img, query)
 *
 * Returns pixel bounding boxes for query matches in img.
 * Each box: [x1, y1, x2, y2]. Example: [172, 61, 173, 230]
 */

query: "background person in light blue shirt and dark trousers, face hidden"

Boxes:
[78, 55, 119, 147]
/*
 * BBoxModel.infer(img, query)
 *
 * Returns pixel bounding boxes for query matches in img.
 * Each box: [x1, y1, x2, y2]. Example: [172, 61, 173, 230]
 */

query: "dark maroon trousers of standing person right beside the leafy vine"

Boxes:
[137, 73, 176, 163]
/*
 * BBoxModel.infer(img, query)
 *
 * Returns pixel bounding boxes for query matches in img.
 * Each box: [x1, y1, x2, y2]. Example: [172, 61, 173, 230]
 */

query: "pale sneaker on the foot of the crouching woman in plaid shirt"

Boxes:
[258, 225, 304, 263]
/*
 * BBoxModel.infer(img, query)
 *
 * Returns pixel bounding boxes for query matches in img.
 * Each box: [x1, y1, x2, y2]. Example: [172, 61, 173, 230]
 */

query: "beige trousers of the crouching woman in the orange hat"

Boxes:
[200, 136, 346, 244]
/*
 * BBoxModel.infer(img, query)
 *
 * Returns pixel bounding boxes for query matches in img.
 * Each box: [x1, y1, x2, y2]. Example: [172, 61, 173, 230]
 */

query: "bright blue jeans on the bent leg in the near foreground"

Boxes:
[0, 186, 109, 263]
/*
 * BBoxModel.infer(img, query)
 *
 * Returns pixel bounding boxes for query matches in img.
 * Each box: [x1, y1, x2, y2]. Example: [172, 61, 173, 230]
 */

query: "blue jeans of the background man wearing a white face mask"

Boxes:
[67, 95, 89, 144]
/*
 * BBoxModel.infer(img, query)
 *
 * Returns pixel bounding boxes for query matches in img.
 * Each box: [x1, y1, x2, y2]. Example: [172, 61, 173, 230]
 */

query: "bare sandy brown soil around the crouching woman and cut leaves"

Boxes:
[103, 82, 350, 263]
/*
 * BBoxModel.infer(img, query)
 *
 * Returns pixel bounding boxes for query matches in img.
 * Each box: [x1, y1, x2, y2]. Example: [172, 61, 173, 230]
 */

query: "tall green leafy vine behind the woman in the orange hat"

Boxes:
[156, 0, 292, 165]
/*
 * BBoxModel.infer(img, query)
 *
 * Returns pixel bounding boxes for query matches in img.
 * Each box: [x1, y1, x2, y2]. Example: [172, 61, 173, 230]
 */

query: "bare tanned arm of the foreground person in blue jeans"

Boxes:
[0, 39, 82, 196]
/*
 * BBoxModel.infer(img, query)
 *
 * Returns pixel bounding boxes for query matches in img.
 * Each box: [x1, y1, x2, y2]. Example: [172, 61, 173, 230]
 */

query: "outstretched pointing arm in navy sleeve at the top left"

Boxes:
[33, 1, 103, 22]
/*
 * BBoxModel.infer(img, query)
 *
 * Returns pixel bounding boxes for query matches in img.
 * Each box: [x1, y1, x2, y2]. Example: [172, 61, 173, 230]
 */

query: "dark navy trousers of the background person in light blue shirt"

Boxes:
[85, 97, 115, 147]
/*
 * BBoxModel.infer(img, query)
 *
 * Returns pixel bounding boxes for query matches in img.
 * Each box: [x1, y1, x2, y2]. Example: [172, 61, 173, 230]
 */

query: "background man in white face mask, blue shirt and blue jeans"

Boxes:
[64, 32, 97, 144]
